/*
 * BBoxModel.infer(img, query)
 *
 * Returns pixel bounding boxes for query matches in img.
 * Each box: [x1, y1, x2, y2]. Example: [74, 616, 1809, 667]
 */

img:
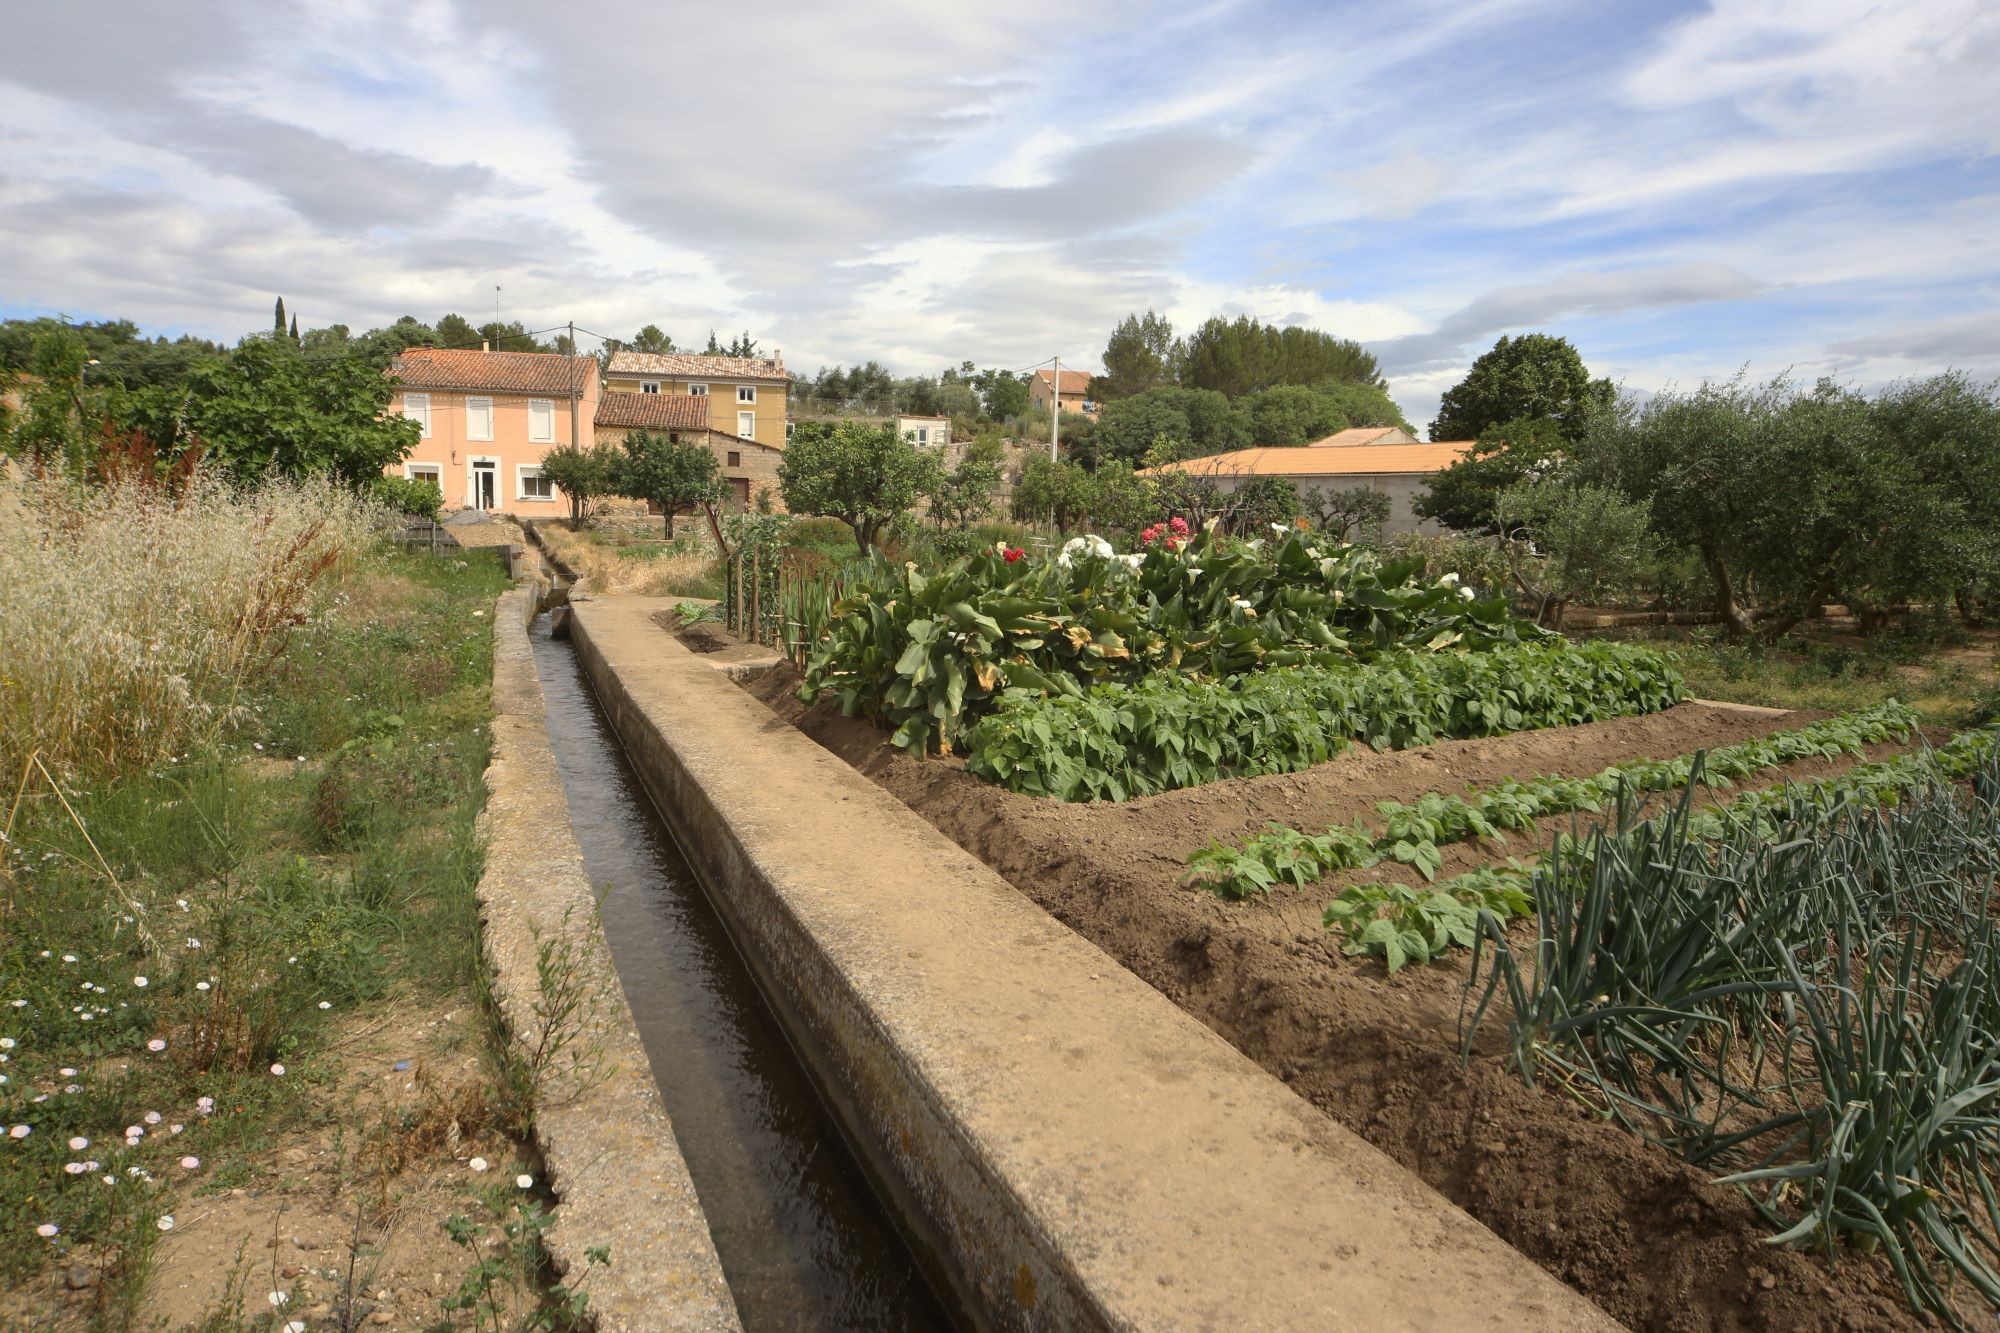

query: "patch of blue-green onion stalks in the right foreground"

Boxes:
[1464, 731, 2000, 1325]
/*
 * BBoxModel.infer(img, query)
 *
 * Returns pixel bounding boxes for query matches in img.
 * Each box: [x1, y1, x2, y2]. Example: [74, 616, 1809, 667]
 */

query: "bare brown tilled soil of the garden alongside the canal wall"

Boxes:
[748, 667, 1922, 1331]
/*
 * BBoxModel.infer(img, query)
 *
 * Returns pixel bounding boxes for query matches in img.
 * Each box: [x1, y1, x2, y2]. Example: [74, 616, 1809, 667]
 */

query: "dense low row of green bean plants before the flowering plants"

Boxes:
[960, 640, 1682, 801]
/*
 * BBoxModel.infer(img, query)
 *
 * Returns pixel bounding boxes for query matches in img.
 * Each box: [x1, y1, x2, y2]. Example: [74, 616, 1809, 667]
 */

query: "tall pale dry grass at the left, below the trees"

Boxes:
[0, 466, 380, 777]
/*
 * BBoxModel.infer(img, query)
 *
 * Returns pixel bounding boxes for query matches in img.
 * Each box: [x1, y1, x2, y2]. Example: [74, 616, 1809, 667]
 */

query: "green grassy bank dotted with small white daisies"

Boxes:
[0, 536, 508, 1327]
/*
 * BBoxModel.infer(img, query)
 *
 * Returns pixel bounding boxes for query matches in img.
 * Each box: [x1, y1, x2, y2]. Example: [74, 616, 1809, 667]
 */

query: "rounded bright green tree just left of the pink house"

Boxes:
[173, 338, 418, 486]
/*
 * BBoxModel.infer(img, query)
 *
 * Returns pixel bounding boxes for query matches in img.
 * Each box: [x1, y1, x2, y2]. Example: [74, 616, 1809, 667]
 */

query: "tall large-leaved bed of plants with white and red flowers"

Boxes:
[802, 528, 1560, 751]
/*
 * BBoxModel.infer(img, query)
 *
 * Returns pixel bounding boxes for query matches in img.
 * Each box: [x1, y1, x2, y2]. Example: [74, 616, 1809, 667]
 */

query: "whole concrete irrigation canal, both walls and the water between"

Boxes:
[480, 588, 1616, 1329]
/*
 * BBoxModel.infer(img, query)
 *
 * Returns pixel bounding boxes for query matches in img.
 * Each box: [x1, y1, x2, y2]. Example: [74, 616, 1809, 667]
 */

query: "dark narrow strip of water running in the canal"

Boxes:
[534, 616, 952, 1333]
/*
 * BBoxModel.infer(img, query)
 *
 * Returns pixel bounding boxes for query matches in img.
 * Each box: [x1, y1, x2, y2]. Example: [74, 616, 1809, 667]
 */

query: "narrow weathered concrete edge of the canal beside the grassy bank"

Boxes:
[478, 588, 740, 1333]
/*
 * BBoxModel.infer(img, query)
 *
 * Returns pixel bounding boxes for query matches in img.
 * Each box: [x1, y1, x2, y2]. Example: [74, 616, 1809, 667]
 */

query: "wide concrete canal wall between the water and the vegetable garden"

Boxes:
[572, 596, 1616, 1329]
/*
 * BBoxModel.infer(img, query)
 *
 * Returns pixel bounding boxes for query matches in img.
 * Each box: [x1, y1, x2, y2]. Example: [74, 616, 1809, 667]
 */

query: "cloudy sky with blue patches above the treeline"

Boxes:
[0, 0, 2000, 426]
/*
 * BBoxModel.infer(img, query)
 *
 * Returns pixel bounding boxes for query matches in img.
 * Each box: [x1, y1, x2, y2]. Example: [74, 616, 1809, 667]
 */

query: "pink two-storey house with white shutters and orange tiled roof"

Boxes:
[388, 346, 598, 518]
